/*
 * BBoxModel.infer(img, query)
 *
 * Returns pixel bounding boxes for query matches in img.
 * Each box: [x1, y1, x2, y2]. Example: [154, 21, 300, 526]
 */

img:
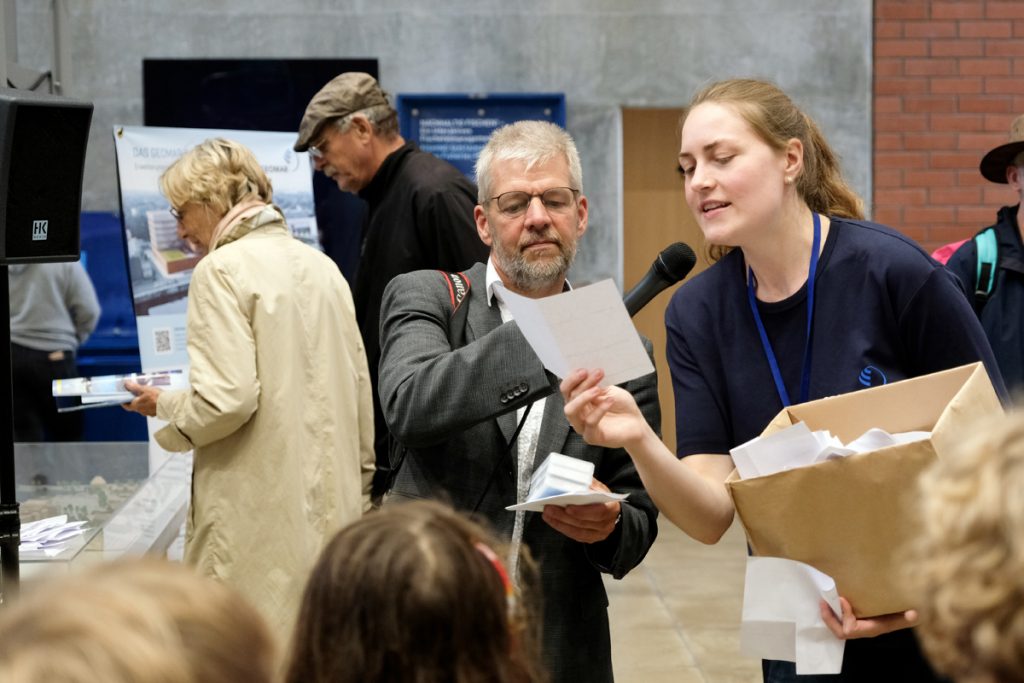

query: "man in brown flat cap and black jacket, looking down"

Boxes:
[295, 72, 488, 497]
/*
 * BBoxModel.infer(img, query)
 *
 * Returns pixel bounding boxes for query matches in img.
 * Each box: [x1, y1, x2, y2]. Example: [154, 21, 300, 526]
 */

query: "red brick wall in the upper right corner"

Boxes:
[871, 0, 1024, 251]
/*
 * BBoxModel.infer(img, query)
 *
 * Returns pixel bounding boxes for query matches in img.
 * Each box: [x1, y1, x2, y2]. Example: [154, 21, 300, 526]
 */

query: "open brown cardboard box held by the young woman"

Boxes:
[726, 362, 1002, 617]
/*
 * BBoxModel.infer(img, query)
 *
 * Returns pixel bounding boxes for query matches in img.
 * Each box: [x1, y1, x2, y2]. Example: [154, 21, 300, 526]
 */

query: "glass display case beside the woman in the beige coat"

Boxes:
[14, 441, 191, 578]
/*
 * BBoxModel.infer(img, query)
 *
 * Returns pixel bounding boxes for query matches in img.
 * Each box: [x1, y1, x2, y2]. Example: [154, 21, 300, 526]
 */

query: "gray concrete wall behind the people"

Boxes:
[8, 0, 871, 280]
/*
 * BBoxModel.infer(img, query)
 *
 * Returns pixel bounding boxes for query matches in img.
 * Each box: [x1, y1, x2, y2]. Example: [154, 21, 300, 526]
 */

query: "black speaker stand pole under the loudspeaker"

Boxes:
[0, 264, 22, 604]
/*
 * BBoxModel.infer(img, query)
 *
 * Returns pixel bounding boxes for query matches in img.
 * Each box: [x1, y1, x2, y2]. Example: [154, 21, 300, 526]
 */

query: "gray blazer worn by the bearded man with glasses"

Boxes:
[379, 263, 662, 682]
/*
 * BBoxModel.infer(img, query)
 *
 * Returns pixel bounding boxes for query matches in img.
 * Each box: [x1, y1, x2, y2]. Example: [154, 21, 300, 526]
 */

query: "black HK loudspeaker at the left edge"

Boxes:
[0, 88, 92, 263]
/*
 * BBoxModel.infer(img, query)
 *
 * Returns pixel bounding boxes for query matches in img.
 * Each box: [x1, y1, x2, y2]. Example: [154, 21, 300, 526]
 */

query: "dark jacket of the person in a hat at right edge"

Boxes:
[946, 205, 1024, 395]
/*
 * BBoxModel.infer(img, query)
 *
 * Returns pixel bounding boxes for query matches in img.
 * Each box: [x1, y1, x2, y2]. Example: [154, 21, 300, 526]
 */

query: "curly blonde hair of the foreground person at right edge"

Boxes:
[906, 412, 1024, 683]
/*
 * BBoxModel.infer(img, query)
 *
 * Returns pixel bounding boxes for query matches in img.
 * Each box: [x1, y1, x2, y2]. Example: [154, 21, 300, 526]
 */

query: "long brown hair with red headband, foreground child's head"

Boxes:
[286, 501, 547, 683]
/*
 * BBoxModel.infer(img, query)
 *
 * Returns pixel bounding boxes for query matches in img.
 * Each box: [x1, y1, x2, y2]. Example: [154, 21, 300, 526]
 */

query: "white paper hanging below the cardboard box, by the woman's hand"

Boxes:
[739, 557, 846, 675]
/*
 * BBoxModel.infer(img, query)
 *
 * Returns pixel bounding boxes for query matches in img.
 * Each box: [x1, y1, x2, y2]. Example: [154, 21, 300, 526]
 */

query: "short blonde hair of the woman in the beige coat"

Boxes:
[160, 137, 273, 222]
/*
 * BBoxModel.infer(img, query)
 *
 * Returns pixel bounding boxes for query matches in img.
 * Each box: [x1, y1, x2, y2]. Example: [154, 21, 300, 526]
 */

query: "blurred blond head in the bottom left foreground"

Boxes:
[0, 558, 276, 683]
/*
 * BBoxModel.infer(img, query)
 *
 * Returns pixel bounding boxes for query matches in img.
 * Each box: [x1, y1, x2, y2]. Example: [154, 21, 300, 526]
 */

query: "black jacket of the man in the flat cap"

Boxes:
[352, 142, 489, 479]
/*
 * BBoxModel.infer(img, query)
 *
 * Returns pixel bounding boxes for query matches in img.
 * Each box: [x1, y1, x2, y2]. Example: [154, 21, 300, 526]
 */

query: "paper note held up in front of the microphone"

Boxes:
[500, 280, 654, 386]
